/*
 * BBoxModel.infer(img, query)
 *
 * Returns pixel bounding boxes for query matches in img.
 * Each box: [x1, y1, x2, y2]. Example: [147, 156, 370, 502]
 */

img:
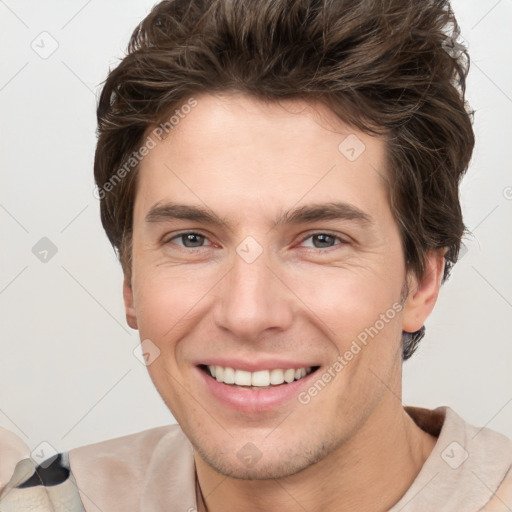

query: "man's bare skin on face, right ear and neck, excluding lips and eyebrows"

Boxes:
[123, 93, 444, 512]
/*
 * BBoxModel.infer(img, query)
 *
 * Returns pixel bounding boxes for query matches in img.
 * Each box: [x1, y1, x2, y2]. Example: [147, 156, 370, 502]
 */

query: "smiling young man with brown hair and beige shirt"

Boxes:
[0, 0, 512, 512]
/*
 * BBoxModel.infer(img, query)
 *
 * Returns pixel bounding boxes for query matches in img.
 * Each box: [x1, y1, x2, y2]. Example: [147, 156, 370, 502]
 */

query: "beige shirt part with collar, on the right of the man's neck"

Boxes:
[391, 406, 512, 512]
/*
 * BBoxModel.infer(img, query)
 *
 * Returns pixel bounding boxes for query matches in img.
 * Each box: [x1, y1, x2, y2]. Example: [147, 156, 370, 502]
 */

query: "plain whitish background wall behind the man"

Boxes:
[0, 0, 512, 450]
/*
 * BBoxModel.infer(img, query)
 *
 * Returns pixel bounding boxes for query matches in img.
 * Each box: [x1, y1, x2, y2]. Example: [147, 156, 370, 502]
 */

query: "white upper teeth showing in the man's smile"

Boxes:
[208, 366, 311, 387]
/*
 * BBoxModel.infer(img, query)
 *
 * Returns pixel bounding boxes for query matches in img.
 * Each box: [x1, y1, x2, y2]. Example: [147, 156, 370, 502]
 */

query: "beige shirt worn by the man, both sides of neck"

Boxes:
[0, 407, 512, 512]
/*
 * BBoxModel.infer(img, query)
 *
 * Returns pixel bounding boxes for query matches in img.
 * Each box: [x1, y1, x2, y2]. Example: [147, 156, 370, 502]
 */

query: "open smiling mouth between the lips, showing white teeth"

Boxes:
[199, 364, 320, 390]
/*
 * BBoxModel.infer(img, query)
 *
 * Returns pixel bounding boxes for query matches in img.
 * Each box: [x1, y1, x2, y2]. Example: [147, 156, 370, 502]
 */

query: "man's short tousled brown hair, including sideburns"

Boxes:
[94, 0, 474, 359]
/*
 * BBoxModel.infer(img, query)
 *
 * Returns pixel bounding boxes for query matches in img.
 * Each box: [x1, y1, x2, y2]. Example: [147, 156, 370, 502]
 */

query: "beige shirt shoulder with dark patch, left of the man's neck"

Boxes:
[0, 425, 196, 512]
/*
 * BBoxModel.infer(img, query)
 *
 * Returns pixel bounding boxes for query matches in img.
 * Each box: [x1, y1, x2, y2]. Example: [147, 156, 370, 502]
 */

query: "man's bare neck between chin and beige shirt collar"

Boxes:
[194, 376, 436, 512]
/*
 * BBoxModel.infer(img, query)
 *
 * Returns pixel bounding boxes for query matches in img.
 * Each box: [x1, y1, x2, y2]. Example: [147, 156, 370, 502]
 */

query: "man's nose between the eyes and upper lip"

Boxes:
[214, 242, 294, 341]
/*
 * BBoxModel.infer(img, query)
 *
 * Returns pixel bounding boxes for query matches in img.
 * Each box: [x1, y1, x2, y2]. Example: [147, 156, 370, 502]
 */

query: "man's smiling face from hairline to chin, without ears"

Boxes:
[128, 94, 421, 478]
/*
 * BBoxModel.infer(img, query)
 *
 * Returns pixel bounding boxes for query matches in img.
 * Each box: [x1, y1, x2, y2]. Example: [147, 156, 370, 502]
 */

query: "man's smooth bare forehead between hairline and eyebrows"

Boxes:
[135, 94, 387, 226]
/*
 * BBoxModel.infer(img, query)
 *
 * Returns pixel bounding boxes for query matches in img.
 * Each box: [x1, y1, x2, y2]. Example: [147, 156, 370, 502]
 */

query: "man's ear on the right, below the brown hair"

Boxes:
[402, 248, 447, 332]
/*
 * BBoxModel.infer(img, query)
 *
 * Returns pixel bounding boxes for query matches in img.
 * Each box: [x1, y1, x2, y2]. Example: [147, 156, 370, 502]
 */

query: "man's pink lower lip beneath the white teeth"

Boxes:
[197, 367, 317, 413]
